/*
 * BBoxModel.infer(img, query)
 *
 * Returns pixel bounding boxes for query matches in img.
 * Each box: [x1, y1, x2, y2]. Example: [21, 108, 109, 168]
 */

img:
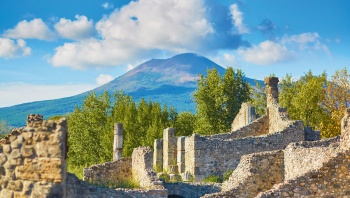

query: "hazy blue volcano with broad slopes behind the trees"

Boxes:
[0, 53, 255, 126]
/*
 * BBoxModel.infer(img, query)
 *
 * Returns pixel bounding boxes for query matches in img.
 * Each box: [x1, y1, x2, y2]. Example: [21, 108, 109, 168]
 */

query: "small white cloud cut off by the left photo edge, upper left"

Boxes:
[0, 37, 31, 59]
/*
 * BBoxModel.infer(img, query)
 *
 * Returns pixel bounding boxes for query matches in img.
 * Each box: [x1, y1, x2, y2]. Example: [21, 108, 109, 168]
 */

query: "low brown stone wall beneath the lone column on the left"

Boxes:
[84, 158, 132, 185]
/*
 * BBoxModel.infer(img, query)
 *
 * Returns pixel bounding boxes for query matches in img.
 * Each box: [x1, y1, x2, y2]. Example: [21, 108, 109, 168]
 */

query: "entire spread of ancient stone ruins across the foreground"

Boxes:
[0, 77, 350, 198]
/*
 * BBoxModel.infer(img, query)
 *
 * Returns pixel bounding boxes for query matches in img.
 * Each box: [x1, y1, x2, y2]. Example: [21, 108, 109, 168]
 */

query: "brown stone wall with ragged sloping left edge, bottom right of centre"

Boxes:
[204, 150, 283, 197]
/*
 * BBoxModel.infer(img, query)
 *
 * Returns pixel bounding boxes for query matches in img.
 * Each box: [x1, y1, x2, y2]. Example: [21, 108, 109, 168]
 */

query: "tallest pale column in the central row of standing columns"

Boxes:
[163, 128, 177, 171]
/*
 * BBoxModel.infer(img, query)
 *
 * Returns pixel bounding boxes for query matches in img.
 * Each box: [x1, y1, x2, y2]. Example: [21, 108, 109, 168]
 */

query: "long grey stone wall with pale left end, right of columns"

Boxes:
[185, 121, 304, 181]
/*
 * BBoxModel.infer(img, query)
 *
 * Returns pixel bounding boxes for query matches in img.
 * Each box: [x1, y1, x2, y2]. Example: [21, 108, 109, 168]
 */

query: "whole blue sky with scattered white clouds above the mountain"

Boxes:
[0, 0, 350, 107]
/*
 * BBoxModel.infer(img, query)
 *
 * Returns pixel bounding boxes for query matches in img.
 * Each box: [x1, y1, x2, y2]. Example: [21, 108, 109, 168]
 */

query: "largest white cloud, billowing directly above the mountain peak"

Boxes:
[51, 0, 213, 69]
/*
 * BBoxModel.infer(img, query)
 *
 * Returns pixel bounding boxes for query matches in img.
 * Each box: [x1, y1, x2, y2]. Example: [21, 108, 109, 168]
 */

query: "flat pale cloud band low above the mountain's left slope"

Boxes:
[0, 83, 96, 107]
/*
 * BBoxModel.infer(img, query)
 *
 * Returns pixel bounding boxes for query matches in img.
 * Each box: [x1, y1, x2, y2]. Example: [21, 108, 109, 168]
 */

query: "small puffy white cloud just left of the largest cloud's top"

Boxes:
[54, 15, 94, 40]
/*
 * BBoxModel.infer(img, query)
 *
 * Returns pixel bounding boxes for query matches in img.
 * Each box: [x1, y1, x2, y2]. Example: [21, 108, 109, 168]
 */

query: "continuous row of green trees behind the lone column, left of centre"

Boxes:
[68, 92, 182, 171]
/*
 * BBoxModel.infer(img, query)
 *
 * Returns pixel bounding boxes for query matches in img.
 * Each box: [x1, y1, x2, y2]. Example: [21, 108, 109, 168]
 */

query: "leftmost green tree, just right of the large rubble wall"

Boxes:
[68, 92, 110, 166]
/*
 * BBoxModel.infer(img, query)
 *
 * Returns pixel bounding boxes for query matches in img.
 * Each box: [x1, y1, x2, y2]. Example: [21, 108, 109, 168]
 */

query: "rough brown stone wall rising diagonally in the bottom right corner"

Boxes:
[257, 108, 350, 198]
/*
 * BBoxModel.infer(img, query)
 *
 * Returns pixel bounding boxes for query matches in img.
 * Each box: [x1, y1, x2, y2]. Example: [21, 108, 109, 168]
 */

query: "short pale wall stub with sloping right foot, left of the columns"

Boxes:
[132, 146, 164, 190]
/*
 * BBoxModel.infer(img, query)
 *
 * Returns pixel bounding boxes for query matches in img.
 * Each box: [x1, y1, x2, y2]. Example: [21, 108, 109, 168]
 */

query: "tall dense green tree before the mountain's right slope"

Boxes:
[194, 68, 250, 134]
